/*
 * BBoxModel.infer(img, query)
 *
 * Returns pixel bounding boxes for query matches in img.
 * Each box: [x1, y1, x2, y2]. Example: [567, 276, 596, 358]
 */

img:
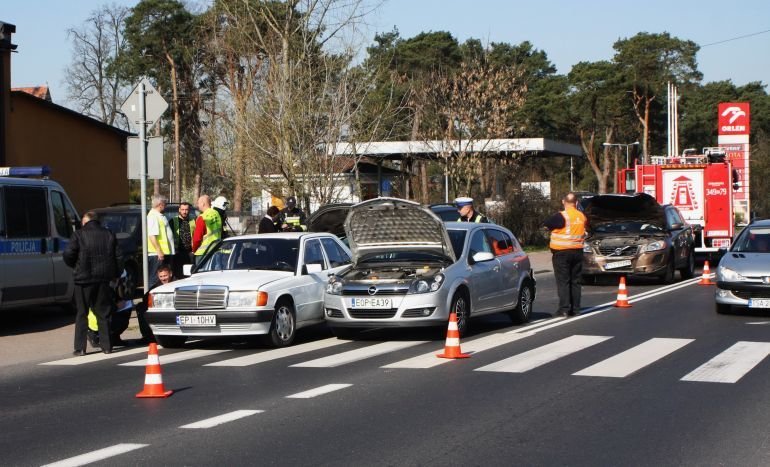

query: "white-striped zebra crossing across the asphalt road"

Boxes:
[41, 328, 770, 383]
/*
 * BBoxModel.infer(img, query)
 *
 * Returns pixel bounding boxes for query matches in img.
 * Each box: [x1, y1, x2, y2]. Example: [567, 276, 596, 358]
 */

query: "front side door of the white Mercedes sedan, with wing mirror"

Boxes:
[292, 238, 329, 323]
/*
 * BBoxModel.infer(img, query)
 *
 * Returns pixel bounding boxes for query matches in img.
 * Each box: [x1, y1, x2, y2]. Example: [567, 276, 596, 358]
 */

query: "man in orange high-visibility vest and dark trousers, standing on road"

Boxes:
[544, 193, 587, 316]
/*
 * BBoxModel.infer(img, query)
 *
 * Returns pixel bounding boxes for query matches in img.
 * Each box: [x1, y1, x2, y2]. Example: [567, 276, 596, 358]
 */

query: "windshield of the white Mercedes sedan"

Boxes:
[197, 238, 299, 272]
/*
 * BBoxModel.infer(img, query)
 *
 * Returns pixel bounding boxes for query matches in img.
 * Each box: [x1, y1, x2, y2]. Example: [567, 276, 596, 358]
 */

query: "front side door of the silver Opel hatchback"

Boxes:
[468, 229, 503, 313]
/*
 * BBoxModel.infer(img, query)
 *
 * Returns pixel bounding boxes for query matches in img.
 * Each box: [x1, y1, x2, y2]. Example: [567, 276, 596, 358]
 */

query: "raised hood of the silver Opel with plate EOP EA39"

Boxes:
[345, 198, 455, 263]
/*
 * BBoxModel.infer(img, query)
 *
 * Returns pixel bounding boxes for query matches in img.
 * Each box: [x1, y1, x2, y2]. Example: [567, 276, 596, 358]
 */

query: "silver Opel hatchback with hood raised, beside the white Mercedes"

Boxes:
[324, 198, 536, 337]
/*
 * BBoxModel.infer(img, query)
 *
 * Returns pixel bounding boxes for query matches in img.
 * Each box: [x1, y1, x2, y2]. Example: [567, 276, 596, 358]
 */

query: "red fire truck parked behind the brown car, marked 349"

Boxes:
[616, 148, 739, 255]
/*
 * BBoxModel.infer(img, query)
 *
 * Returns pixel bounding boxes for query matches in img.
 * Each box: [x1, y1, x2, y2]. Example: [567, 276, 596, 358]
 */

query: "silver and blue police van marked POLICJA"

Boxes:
[0, 167, 80, 310]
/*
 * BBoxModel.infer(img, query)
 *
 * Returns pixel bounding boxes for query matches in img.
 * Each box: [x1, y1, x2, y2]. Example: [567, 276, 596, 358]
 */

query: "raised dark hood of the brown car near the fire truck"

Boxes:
[583, 193, 666, 229]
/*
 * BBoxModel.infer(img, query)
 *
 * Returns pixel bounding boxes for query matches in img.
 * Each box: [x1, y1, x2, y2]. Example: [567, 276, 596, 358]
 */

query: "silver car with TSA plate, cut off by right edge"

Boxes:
[714, 219, 770, 313]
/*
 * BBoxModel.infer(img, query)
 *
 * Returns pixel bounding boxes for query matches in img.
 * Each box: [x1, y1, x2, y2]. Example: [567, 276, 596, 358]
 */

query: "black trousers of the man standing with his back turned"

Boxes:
[75, 282, 115, 350]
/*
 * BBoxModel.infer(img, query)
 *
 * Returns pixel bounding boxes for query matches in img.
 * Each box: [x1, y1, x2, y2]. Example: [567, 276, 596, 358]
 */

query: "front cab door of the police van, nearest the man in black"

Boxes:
[49, 190, 80, 301]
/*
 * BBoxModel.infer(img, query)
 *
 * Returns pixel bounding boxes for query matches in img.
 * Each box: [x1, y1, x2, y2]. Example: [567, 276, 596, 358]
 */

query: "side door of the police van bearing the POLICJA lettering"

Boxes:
[0, 185, 54, 307]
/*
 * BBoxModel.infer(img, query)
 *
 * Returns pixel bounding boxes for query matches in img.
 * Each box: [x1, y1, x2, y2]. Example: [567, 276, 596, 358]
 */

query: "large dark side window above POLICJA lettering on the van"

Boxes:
[5, 186, 48, 238]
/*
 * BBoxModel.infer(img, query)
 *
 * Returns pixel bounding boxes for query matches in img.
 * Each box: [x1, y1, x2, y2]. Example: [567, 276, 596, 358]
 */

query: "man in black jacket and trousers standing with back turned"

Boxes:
[63, 211, 123, 355]
